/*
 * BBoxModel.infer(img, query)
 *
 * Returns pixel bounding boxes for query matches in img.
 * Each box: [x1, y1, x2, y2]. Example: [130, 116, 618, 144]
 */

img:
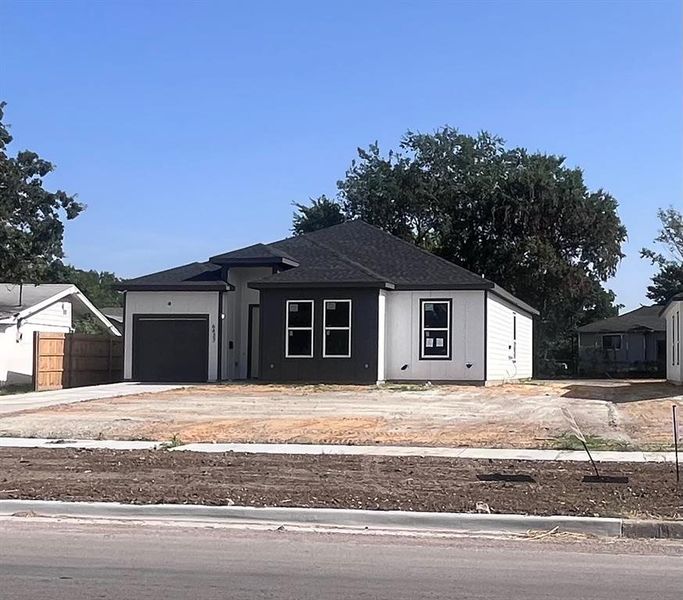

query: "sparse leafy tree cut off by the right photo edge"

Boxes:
[640, 207, 683, 304]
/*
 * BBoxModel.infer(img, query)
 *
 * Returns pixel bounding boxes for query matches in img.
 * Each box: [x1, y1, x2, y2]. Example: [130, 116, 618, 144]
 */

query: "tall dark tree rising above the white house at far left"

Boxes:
[0, 102, 85, 283]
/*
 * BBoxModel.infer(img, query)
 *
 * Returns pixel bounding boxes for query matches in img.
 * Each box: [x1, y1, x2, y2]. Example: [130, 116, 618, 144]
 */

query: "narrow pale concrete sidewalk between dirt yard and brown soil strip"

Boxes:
[0, 438, 675, 463]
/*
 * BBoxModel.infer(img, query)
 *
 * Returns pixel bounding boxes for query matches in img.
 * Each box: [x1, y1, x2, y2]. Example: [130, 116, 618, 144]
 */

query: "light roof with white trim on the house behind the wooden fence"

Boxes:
[0, 283, 121, 336]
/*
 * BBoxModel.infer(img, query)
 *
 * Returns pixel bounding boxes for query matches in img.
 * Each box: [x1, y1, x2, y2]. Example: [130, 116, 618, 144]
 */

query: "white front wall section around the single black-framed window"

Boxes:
[384, 290, 484, 381]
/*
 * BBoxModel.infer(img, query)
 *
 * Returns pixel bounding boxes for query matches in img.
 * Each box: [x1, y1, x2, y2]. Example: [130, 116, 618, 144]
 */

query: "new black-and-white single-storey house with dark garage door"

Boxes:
[118, 220, 538, 383]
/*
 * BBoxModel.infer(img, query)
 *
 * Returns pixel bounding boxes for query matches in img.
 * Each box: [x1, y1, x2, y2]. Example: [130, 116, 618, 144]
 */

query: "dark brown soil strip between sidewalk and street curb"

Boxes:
[0, 448, 683, 519]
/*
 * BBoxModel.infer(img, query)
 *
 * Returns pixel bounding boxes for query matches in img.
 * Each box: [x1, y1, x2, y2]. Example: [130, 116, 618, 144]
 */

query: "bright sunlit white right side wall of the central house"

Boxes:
[486, 293, 533, 381]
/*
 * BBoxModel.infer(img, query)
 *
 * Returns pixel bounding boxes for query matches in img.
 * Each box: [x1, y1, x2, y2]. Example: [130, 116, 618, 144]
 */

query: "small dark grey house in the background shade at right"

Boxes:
[578, 305, 666, 377]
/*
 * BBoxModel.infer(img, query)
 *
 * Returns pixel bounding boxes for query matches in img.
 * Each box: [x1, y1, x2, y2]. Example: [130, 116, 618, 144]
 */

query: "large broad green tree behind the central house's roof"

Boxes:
[296, 127, 626, 366]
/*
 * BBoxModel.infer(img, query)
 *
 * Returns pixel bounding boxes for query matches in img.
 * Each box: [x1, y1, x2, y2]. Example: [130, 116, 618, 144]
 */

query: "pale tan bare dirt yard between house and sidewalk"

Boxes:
[0, 380, 683, 450]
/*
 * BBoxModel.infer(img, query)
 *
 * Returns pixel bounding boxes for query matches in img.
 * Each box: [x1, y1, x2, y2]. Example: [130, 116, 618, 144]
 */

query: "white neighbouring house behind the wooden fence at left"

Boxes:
[0, 283, 120, 386]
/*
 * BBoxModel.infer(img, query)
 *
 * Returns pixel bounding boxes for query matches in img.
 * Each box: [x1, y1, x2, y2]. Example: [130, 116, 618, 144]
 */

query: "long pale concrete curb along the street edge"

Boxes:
[0, 500, 624, 537]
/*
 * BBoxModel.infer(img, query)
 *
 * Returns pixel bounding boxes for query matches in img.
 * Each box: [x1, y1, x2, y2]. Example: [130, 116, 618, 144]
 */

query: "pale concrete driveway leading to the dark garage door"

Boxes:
[0, 382, 182, 415]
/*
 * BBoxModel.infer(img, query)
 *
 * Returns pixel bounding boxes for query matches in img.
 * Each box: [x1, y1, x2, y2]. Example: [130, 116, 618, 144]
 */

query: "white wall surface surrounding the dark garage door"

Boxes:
[123, 292, 218, 381]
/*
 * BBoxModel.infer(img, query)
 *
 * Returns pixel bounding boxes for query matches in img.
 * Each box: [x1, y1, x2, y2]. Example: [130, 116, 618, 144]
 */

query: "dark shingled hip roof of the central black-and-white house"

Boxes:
[119, 219, 538, 314]
